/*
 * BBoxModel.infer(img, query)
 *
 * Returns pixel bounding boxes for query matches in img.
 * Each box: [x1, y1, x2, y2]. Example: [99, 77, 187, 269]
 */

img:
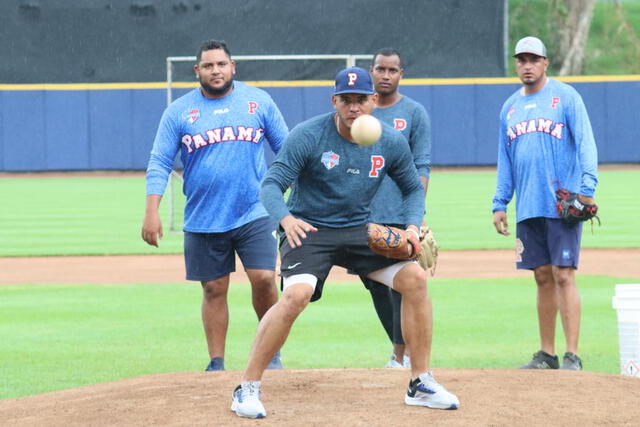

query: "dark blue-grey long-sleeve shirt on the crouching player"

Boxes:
[261, 113, 424, 228]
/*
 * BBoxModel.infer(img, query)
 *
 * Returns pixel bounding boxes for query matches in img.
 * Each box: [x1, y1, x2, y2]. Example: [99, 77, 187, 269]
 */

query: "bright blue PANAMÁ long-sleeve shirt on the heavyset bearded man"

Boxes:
[147, 81, 288, 233]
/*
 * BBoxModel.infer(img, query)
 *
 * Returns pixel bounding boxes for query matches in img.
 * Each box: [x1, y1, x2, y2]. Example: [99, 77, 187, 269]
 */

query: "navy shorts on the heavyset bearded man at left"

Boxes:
[184, 217, 277, 282]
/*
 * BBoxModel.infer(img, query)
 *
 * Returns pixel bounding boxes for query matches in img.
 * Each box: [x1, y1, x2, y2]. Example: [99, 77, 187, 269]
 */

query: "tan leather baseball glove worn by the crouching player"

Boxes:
[367, 223, 420, 259]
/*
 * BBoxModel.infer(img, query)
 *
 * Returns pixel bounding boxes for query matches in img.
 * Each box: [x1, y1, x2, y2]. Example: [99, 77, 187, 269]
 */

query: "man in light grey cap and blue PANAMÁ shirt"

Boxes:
[493, 37, 598, 370]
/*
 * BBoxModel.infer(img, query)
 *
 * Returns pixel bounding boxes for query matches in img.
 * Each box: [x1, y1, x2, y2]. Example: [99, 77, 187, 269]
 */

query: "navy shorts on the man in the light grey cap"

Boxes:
[516, 218, 582, 270]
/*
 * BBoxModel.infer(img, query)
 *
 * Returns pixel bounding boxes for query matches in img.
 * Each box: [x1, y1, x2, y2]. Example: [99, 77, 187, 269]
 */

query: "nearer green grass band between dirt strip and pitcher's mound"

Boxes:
[0, 276, 637, 399]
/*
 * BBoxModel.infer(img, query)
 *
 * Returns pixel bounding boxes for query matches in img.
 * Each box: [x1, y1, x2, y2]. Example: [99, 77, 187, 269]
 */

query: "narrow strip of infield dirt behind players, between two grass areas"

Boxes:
[0, 249, 640, 285]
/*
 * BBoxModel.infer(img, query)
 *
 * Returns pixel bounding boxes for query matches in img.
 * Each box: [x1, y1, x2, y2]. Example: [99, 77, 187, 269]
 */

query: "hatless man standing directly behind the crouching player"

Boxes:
[362, 48, 431, 368]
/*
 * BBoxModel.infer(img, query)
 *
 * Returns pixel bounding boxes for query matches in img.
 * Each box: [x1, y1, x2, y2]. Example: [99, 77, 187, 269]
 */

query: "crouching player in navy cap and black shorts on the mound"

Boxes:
[231, 67, 460, 418]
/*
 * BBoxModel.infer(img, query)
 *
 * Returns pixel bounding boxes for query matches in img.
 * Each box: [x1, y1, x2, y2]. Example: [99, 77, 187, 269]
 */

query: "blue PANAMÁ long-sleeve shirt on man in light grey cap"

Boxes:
[493, 79, 598, 222]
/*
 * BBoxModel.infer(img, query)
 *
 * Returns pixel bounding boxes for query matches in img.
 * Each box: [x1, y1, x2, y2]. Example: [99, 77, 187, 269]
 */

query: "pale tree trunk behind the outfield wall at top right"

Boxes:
[552, 0, 596, 76]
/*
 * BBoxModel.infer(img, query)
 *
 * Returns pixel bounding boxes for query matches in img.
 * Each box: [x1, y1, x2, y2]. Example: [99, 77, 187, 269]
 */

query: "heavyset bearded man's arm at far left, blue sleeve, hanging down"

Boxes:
[141, 109, 180, 247]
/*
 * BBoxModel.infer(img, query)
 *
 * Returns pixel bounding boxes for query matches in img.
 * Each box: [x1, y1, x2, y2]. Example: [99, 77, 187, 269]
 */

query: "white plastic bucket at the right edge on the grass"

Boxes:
[613, 284, 640, 378]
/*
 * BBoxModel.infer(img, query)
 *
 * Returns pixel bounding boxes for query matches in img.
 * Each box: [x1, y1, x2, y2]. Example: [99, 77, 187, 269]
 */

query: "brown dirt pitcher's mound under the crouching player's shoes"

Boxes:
[0, 369, 640, 427]
